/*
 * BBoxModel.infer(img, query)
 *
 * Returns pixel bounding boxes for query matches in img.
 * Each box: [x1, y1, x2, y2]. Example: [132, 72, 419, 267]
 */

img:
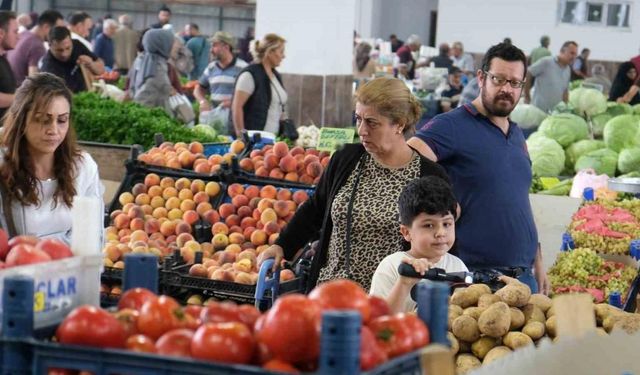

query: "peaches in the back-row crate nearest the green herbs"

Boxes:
[138, 140, 245, 174]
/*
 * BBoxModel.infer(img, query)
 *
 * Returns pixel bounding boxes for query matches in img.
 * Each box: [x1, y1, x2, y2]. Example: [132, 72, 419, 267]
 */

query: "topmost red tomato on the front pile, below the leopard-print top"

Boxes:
[309, 279, 371, 323]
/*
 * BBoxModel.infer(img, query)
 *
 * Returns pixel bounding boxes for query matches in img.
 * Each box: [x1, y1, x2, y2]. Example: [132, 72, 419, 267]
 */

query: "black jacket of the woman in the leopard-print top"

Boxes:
[276, 143, 449, 292]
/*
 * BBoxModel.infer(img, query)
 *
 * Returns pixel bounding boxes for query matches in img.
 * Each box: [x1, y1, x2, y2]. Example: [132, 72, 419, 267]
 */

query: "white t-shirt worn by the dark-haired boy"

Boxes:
[369, 251, 469, 312]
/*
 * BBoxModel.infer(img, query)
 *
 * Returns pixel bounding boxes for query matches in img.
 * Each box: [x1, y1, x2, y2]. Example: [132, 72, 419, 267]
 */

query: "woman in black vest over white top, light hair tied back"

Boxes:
[231, 34, 287, 137]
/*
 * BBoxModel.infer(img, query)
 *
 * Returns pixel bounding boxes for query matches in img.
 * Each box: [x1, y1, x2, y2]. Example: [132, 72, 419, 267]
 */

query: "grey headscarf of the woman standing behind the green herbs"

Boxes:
[134, 29, 174, 91]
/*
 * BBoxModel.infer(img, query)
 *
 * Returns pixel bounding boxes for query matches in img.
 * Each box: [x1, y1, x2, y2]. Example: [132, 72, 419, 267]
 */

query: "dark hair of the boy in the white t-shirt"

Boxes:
[398, 176, 458, 226]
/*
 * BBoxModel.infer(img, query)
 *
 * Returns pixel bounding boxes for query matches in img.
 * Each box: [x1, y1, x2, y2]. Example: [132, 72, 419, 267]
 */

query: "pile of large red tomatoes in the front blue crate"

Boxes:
[51, 280, 429, 373]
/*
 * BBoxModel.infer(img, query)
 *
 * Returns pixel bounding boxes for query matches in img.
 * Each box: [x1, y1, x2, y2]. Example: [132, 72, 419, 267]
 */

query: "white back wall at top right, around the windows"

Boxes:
[437, 0, 640, 61]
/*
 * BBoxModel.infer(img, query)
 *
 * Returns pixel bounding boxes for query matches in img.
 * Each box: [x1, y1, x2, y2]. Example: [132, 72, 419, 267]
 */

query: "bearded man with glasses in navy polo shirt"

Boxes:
[408, 43, 549, 293]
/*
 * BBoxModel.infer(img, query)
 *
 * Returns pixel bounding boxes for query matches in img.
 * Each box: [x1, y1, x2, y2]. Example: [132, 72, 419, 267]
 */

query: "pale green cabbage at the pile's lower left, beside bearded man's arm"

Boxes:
[527, 136, 565, 177]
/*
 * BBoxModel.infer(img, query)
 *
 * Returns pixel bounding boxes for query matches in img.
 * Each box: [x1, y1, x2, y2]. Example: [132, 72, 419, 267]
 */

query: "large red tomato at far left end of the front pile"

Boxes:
[56, 305, 127, 348]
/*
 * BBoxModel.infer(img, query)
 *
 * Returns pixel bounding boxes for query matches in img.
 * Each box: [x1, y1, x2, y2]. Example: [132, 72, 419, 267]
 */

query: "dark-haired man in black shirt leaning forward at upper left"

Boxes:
[42, 26, 104, 93]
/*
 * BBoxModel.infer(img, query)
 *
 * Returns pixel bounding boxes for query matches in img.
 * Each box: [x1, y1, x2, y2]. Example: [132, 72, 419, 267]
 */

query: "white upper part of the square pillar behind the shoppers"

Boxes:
[256, 0, 356, 75]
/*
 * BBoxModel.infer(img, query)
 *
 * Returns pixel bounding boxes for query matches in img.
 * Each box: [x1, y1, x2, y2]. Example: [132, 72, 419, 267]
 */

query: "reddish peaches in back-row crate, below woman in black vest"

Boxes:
[239, 142, 331, 185]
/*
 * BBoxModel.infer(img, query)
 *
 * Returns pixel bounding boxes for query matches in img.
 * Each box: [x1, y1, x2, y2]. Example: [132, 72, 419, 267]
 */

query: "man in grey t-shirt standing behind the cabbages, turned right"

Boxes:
[524, 41, 578, 112]
